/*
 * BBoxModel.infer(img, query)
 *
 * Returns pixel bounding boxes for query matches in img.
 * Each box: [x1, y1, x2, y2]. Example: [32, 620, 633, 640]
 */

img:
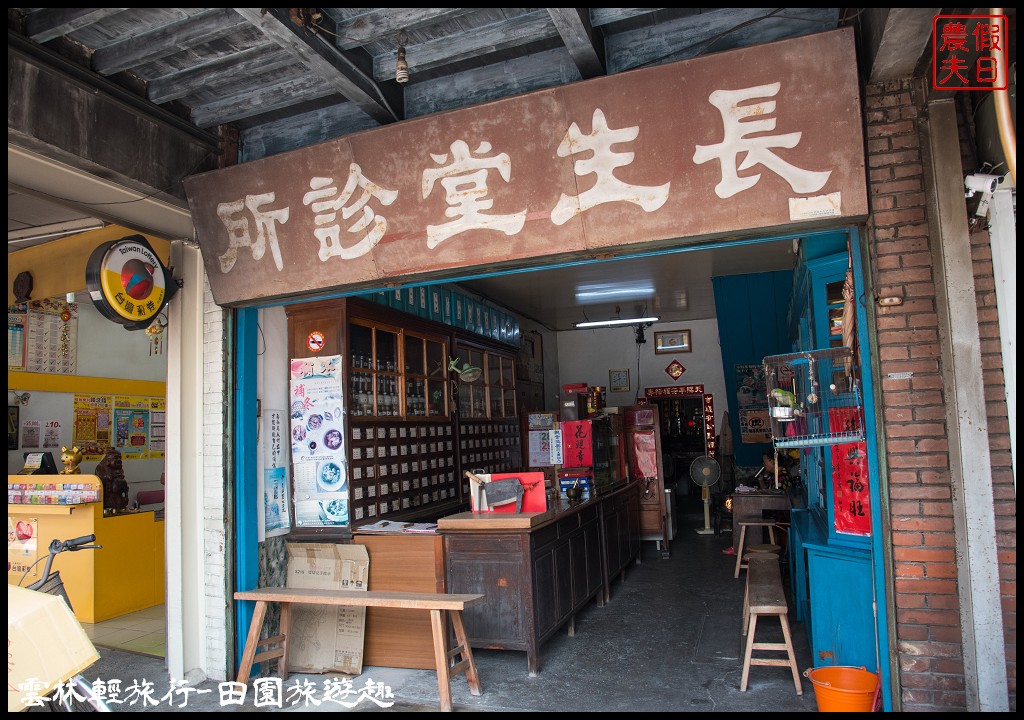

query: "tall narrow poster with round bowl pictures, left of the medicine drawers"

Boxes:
[289, 355, 349, 527]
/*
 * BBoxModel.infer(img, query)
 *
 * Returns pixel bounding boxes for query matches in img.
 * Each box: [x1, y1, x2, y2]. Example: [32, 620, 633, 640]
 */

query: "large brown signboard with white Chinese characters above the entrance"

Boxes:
[185, 30, 867, 305]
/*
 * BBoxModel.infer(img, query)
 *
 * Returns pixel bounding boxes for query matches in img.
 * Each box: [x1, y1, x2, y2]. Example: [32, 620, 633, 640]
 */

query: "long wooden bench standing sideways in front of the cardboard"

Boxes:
[234, 588, 483, 712]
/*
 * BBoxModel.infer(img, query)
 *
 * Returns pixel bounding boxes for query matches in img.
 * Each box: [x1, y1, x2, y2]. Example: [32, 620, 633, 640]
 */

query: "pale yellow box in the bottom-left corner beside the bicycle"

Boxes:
[7, 585, 99, 712]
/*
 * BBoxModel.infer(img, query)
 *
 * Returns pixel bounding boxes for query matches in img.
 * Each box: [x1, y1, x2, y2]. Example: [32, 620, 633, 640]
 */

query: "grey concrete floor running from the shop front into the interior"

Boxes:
[85, 503, 817, 713]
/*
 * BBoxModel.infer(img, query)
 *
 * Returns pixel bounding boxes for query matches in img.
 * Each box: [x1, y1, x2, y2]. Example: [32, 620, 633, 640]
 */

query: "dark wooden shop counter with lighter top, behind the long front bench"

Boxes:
[437, 482, 640, 675]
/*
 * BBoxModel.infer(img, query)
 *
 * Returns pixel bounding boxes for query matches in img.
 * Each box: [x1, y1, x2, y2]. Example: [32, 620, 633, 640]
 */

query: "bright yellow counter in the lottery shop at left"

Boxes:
[7, 475, 164, 623]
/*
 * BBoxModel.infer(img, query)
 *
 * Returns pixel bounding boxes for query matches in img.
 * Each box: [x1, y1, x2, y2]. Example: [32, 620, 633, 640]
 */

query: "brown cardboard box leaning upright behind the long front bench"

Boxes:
[286, 543, 370, 675]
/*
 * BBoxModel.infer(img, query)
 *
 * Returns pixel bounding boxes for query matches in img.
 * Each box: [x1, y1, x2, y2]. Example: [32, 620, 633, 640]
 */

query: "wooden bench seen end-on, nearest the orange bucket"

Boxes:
[739, 553, 804, 695]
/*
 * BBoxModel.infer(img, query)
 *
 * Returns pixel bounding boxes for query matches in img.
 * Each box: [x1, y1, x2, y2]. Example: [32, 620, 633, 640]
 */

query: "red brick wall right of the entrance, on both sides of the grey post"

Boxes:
[864, 81, 1016, 711]
